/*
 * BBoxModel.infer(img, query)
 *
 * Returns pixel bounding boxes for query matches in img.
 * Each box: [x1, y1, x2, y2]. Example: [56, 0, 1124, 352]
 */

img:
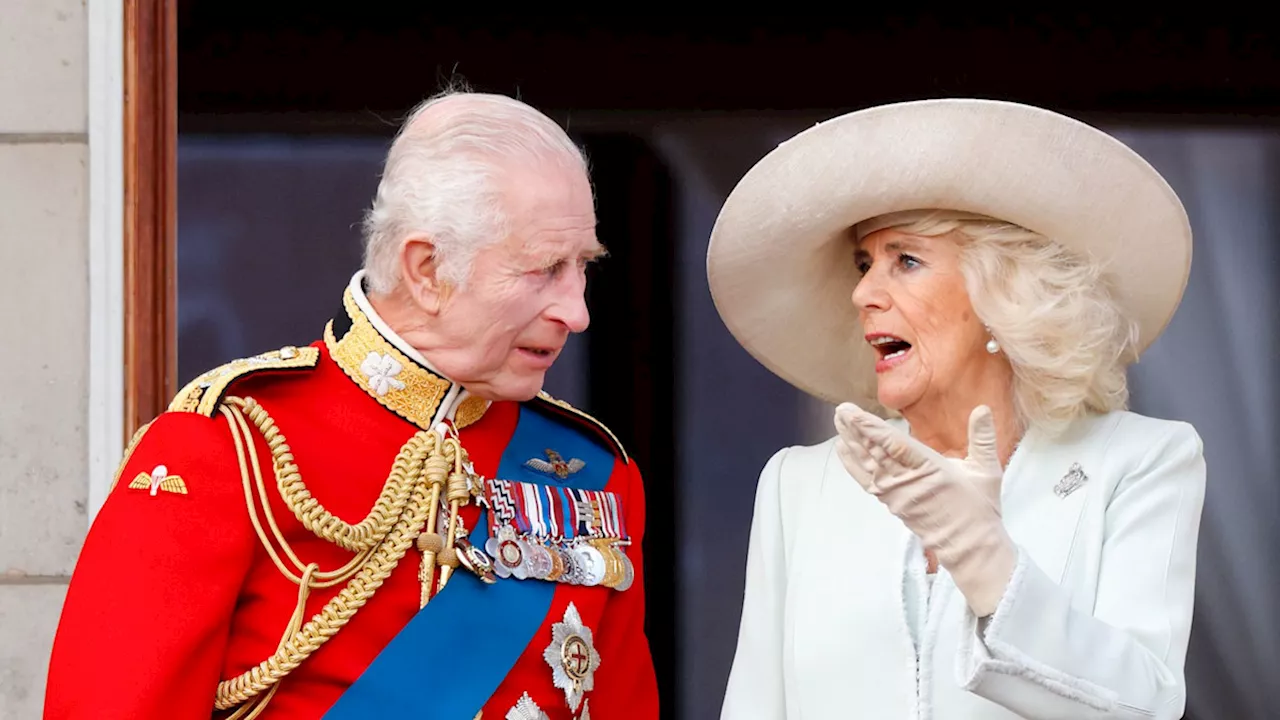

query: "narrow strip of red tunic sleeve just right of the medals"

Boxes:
[588, 460, 658, 720]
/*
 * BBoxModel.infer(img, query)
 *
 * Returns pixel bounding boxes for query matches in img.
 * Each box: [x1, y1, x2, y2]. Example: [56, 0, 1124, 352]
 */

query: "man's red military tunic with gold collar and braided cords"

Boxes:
[45, 275, 658, 720]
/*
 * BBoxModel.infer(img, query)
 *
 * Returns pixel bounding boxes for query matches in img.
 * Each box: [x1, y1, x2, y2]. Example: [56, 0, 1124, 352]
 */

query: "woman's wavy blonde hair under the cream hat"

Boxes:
[859, 210, 1138, 434]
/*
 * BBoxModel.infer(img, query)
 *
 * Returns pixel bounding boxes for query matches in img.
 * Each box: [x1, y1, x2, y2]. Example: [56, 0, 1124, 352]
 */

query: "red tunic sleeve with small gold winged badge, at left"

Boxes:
[45, 413, 257, 720]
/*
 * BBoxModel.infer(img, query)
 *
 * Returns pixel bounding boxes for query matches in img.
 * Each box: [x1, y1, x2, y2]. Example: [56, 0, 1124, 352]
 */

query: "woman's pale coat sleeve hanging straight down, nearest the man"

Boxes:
[721, 448, 787, 720]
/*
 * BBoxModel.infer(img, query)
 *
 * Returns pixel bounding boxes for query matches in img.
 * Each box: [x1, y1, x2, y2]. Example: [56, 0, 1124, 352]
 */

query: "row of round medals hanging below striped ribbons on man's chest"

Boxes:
[485, 524, 635, 591]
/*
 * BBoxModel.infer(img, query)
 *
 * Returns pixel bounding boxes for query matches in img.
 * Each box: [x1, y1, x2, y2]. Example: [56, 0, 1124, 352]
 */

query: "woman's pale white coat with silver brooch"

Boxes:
[721, 413, 1206, 720]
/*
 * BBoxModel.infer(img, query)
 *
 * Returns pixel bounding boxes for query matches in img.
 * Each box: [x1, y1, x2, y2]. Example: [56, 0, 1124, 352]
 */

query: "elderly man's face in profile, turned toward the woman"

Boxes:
[431, 159, 604, 401]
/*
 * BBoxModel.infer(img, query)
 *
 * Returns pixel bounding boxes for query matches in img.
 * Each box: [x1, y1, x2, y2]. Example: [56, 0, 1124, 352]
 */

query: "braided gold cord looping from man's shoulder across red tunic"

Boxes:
[214, 397, 470, 720]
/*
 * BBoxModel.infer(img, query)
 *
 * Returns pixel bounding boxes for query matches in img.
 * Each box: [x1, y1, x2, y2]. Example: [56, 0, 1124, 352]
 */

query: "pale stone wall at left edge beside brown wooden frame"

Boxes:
[0, 0, 123, 720]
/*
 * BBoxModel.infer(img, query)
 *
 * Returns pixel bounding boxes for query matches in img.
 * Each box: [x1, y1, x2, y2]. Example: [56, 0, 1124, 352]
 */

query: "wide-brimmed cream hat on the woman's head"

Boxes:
[707, 99, 1192, 414]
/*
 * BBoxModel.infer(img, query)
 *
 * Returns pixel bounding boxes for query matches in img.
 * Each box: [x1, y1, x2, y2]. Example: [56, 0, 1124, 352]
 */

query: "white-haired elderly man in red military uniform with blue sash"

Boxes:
[45, 94, 658, 720]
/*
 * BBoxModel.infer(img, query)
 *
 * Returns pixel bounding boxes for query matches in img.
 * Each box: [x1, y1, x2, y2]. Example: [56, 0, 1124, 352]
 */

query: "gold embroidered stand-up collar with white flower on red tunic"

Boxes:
[324, 278, 489, 429]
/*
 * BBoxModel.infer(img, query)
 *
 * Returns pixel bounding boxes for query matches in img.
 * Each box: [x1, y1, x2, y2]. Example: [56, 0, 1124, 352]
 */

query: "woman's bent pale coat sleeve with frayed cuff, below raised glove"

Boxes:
[957, 423, 1206, 720]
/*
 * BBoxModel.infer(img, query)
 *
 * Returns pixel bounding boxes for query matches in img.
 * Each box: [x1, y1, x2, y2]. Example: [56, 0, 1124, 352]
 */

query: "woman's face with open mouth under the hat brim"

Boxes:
[852, 228, 1001, 413]
